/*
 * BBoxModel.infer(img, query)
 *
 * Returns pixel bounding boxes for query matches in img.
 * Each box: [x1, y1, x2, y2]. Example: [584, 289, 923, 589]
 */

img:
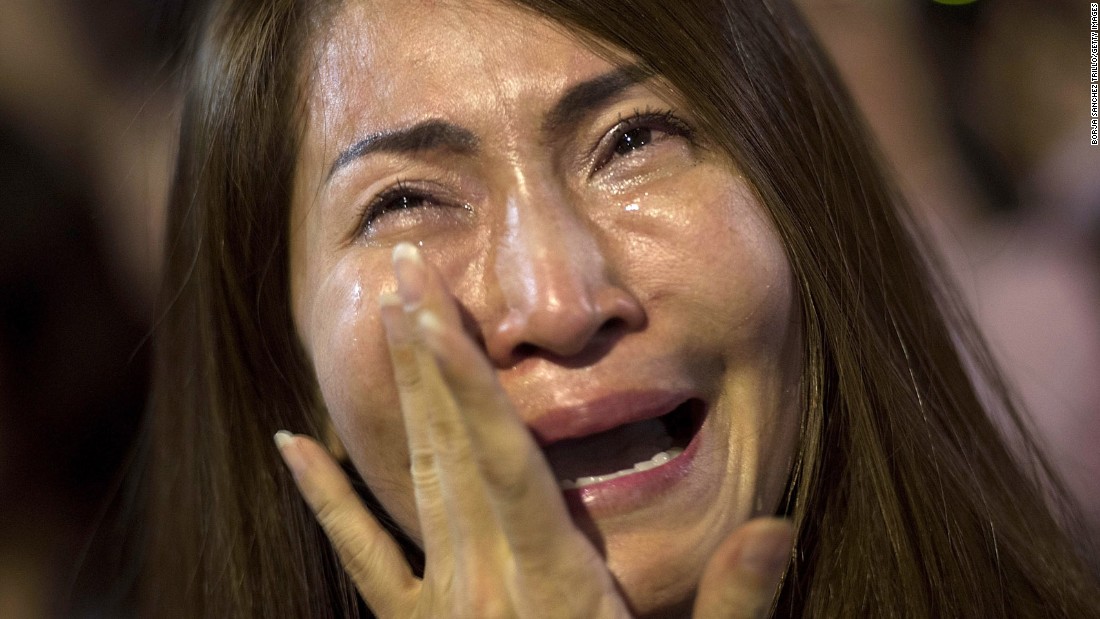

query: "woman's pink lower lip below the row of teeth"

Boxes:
[562, 406, 706, 517]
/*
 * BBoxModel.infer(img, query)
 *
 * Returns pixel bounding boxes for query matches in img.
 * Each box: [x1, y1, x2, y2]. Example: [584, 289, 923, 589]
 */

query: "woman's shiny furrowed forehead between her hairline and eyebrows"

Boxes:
[309, 0, 629, 140]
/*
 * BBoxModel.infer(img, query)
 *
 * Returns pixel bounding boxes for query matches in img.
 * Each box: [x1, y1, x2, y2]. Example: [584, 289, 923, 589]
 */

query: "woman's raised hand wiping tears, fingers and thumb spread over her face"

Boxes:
[276, 244, 791, 619]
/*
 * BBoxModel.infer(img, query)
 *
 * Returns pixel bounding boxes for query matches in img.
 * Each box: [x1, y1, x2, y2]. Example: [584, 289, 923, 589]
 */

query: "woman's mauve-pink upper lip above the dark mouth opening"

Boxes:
[529, 389, 692, 446]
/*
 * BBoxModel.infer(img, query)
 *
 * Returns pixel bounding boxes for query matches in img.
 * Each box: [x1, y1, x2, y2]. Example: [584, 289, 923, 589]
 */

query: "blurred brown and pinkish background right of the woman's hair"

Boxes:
[798, 0, 1100, 543]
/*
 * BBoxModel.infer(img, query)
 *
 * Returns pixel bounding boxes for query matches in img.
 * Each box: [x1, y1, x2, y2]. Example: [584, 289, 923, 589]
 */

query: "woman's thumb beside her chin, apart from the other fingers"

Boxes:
[692, 518, 794, 619]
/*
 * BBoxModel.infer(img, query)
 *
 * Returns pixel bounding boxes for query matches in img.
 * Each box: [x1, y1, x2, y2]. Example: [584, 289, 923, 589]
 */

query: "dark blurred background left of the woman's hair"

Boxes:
[0, 0, 196, 619]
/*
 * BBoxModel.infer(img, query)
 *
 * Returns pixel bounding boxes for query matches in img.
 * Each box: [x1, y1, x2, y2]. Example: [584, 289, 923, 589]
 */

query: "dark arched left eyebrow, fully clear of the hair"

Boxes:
[327, 120, 477, 178]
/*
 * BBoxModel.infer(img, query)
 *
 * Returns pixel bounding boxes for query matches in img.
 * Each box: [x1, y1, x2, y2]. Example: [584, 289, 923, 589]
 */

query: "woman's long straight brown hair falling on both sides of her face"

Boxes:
[144, 0, 1100, 617]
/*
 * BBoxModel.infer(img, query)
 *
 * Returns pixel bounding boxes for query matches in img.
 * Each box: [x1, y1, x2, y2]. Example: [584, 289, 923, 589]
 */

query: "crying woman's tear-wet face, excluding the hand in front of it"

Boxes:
[290, 0, 801, 611]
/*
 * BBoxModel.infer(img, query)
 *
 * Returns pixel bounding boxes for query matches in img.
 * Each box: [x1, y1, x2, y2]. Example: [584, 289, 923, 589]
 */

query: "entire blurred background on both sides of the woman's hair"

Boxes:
[0, 0, 1100, 619]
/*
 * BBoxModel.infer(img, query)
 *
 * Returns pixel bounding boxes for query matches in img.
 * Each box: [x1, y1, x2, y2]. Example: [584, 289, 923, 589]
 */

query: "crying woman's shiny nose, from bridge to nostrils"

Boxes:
[485, 188, 646, 367]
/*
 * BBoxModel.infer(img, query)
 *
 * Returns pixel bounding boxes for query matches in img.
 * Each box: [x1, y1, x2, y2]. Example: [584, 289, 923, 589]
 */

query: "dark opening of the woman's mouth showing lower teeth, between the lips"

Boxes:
[543, 399, 705, 490]
